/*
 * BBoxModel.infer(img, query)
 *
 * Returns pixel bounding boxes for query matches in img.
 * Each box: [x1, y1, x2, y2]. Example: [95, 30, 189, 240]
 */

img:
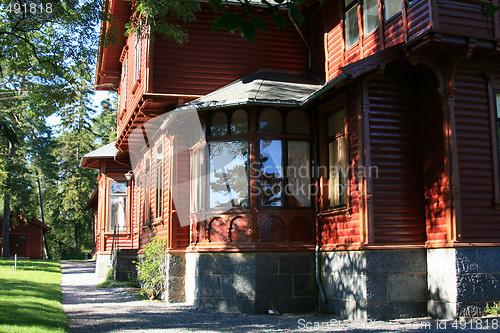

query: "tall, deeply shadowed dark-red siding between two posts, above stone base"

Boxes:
[369, 68, 425, 243]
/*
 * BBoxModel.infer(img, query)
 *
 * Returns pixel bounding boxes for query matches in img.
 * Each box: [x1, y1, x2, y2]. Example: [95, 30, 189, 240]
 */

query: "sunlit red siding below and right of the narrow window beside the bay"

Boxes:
[319, 88, 361, 245]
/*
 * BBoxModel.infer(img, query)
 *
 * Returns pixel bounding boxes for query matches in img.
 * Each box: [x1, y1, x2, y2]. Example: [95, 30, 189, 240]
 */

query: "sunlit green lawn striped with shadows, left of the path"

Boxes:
[0, 259, 68, 332]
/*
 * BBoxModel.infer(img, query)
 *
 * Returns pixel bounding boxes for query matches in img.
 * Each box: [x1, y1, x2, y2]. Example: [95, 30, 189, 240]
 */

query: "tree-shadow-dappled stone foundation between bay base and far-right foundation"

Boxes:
[321, 249, 427, 320]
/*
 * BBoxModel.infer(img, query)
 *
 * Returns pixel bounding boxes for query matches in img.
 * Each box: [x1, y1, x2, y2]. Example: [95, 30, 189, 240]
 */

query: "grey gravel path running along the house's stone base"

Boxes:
[61, 261, 500, 333]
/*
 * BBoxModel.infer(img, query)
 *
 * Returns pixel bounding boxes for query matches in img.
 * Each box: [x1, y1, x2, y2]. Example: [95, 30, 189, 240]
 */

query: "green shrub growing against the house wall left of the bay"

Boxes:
[137, 237, 167, 300]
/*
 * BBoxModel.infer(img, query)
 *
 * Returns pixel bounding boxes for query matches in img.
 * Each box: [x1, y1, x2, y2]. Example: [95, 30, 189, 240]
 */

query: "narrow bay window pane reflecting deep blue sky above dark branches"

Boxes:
[260, 140, 283, 206]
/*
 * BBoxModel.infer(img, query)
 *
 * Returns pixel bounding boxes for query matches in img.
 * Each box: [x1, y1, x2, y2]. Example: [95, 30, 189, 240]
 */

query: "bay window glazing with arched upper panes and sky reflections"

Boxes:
[191, 108, 311, 212]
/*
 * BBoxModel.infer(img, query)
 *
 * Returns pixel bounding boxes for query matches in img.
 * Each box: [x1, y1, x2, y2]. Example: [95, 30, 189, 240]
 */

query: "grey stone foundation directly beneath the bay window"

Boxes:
[185, 252, 318, 313]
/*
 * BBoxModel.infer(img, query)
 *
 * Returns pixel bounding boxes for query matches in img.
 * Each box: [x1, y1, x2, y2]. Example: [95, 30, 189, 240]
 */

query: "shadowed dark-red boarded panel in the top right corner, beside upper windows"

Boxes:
[438, 0, 498, 37]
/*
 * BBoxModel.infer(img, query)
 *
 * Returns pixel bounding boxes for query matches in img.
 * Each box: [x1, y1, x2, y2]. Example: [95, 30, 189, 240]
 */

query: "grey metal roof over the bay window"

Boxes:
[178, 69, 322, 111]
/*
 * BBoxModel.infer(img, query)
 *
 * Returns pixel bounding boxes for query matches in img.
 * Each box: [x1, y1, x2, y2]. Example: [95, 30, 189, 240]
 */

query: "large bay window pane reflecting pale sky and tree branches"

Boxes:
[209, 140, 249, 210]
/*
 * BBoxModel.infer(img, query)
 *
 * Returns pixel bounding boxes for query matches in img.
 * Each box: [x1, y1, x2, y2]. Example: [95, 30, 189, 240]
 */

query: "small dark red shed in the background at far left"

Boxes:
[0, 215, 50, 259]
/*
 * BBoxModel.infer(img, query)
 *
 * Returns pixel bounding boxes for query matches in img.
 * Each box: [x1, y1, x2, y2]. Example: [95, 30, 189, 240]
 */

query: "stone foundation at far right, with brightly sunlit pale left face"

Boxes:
[427, 247, 500, 319]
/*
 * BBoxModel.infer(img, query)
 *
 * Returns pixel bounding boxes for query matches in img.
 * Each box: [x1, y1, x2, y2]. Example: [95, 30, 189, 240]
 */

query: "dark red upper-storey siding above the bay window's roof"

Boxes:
[151, 5, 308, 95]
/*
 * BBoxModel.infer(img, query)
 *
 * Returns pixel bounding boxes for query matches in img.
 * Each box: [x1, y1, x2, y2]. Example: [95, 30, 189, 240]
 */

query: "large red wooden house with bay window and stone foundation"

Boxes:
[82, 0, 500, 318]
